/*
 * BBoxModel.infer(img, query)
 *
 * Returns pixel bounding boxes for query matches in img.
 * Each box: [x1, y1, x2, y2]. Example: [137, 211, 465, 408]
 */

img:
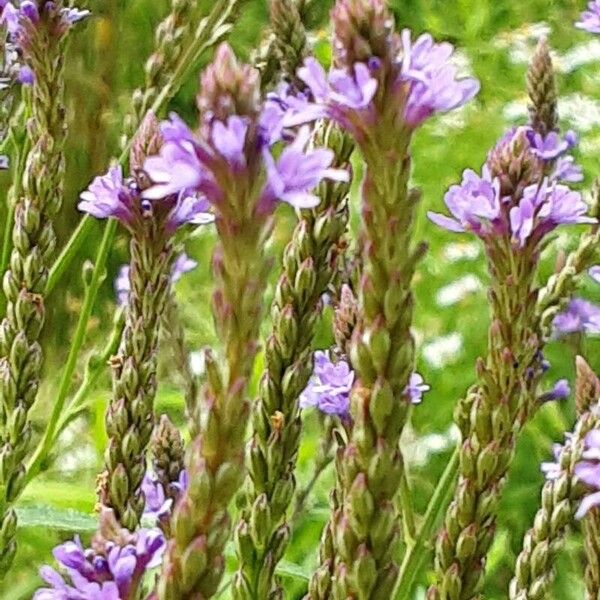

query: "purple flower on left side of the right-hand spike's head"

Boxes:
[427, 167, 500, 237]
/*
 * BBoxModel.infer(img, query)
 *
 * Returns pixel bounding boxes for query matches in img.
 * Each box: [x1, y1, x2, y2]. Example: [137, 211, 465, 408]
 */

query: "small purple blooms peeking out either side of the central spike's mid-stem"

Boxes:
[300, 350, 430, 418]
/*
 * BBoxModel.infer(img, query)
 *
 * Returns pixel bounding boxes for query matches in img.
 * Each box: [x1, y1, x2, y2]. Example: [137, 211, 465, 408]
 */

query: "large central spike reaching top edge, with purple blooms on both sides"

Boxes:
[284, 0, 478, 600]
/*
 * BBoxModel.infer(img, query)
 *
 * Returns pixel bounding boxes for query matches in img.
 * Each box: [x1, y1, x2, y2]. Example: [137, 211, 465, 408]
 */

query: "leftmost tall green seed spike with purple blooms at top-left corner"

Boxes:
[0, 2, 87, 579]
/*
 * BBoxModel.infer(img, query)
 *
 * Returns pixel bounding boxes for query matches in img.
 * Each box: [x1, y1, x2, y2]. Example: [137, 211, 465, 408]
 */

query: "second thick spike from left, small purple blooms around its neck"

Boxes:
[79, 113, 207, 531]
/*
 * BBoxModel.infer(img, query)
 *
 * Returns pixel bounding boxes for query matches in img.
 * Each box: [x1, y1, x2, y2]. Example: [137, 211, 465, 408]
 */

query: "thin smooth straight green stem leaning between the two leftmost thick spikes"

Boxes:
[27, 219, 117, 482]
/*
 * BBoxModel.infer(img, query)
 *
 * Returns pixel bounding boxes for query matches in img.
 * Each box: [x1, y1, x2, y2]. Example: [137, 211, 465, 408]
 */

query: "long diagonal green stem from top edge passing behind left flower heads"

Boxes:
[46, 0, 237, 295]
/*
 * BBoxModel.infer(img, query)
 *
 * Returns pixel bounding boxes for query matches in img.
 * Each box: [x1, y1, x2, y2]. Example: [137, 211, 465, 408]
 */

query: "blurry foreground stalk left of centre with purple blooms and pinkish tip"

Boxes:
[145, 45, 348, 600]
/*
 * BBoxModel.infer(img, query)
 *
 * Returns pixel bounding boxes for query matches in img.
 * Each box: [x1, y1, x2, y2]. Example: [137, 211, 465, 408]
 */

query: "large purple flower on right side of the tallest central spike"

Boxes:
[400, 29, 479, 128]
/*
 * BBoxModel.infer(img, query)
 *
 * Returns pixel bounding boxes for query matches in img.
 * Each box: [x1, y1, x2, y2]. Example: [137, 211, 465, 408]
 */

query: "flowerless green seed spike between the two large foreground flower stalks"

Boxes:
[234, 125, 353, 600]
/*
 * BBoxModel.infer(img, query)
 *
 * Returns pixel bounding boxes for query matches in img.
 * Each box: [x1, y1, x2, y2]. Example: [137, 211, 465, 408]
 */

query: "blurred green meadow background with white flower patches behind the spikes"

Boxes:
[0, 0, 600, 600]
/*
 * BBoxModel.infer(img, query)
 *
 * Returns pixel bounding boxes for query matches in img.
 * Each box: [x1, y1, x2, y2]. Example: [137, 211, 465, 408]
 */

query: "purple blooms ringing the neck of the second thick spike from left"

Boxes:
[77, 166, 213, 233]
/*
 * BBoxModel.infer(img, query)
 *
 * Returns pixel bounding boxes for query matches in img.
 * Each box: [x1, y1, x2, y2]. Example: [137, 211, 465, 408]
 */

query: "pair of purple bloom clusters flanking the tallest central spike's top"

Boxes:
[282, 29, 479, 141]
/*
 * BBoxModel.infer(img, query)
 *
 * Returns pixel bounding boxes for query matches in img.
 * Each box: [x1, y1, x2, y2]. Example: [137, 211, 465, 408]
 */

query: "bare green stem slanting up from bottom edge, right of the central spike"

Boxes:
[392, 448, 459, 600]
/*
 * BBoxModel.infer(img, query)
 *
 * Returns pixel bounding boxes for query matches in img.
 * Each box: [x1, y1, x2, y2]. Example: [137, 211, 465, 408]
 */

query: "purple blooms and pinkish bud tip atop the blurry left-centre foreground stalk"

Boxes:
[143, 50, 349, 214]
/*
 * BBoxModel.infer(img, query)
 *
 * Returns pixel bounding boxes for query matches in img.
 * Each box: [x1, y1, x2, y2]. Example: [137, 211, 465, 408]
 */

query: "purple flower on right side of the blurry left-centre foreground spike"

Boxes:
[262, 127, 350, 208]
